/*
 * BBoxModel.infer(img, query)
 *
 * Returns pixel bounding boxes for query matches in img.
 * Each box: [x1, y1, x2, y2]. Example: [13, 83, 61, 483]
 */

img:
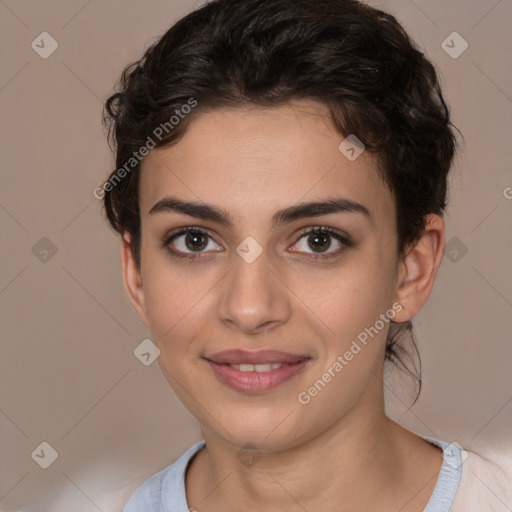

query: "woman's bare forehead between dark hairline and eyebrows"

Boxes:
[139, 101, 394, 224]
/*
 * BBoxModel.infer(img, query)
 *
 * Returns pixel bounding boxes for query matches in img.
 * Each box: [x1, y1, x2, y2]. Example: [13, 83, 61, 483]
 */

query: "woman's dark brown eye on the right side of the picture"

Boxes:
[290, 226, 352, 258]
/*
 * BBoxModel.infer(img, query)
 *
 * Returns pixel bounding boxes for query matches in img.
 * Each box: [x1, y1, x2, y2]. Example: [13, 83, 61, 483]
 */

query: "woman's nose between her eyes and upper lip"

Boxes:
[217, 252, 291, 334]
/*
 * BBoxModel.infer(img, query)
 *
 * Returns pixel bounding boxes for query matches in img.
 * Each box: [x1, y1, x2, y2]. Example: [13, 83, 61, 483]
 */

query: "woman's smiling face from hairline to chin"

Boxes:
[127, 102, 408, 450]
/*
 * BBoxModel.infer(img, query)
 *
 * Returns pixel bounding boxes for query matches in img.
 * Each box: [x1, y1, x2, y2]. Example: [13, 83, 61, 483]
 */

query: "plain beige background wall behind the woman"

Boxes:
[0, 0, 512, 512]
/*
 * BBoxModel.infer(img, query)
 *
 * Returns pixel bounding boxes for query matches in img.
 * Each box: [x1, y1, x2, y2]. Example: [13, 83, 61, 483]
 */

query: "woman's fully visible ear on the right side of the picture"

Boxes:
[394, 214, 444, 322]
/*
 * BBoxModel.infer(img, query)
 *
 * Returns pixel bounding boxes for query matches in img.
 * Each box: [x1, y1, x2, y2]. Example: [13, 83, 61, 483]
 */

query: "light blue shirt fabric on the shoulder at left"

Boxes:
[123, 441, 205, 512]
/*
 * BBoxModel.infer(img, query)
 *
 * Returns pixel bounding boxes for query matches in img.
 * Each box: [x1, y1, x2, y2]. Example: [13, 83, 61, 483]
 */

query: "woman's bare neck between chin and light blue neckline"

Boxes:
[186, 384, 441, 512]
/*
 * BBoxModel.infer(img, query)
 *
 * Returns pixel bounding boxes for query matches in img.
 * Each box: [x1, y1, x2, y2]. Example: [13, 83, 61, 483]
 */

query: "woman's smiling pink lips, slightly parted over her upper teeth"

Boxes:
[205, 350, 311, 394]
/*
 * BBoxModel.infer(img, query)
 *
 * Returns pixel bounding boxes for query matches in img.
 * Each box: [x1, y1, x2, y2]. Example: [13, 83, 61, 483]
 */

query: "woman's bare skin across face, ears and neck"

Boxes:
[121, 101, 444, 512]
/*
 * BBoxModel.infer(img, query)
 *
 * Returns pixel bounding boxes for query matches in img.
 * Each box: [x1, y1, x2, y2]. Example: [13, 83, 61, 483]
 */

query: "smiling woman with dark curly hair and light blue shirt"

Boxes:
[102, 0, 496, 512]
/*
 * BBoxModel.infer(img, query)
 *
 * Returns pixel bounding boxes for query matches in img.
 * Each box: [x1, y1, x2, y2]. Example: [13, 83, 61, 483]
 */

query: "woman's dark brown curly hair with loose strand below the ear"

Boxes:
[102, 0, 457, 395]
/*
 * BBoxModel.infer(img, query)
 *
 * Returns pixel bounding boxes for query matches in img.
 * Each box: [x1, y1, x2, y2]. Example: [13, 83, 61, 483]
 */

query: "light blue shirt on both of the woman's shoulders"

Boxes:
[123, 438, 462, 512]
